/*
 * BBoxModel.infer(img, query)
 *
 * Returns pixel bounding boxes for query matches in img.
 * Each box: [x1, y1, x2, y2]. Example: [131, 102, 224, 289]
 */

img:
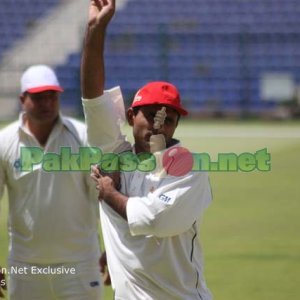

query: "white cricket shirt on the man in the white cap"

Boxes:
[0, 114, 100, 264]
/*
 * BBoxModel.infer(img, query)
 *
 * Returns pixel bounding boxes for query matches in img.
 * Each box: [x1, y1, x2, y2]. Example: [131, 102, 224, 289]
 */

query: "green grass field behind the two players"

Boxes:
[0, 121, 300, 300]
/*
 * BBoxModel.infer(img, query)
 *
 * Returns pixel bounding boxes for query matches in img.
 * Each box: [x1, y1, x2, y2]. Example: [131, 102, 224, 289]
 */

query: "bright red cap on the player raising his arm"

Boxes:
[131, 81, 188, 116]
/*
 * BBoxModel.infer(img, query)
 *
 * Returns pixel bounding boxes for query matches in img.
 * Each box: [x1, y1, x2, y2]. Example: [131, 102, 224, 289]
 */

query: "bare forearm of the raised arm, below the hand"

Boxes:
[81, 24, 106, 99]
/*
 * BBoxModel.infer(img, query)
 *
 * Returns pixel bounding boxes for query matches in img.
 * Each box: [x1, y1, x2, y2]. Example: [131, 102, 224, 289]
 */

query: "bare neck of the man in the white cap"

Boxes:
[24, 118, 57, 146]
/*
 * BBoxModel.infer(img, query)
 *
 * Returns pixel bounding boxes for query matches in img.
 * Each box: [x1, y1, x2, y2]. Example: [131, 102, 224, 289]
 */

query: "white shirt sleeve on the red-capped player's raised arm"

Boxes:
[82, 87, 131, 152]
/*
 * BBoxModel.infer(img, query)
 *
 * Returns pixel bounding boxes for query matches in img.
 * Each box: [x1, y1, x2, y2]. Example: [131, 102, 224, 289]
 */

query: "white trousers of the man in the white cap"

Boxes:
[8, 260, 102, 300]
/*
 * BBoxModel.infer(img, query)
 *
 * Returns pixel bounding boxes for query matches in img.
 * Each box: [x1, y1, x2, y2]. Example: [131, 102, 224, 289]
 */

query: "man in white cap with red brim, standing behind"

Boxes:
[0, 65, 106, 300]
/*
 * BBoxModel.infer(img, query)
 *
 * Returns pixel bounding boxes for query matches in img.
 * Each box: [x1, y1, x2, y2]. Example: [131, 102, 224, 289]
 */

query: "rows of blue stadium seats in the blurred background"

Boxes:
[0, 0, 300, 112]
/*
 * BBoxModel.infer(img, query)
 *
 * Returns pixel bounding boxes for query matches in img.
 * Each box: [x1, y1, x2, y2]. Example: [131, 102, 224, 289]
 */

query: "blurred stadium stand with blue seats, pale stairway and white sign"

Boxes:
[0, 0, 300, 119]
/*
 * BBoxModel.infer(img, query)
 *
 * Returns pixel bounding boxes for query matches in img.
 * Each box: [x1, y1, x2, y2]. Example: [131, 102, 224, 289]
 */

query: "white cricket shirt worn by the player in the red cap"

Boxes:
[83, 88, 211, 300]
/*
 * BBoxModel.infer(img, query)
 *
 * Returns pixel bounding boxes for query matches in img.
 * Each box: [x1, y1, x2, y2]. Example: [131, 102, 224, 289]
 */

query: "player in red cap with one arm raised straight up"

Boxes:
[82, 0, 211, 300]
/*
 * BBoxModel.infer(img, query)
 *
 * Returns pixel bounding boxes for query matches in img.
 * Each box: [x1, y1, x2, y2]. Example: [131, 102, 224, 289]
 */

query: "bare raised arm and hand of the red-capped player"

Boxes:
[81, 0, 115, 99]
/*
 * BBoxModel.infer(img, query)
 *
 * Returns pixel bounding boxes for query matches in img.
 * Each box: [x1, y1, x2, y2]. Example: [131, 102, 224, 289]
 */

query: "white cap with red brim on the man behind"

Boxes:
[21, 65, 63, 94]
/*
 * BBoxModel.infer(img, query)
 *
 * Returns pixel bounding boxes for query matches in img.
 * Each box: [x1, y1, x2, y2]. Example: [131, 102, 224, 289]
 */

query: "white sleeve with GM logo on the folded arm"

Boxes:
[127, 172, 212, 237]
